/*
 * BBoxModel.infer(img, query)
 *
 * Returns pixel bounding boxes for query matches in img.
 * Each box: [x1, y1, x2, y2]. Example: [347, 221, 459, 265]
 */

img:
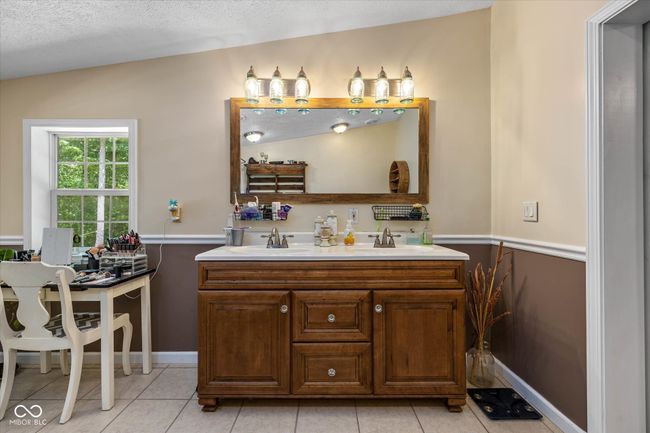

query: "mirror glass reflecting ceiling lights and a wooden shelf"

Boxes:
[240, 108, 419, 194]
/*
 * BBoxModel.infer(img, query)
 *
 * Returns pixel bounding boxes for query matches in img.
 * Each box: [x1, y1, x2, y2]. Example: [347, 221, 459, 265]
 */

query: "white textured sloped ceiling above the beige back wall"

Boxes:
[0, 0, 492, 79]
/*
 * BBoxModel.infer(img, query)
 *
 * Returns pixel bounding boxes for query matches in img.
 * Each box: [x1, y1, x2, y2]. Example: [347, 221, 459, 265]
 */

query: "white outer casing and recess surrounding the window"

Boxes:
[23, 119, 138, 249]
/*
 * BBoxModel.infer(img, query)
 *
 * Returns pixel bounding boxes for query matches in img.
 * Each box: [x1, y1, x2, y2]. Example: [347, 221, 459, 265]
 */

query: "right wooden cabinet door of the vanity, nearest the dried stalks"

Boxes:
[373, 290, 465, 395]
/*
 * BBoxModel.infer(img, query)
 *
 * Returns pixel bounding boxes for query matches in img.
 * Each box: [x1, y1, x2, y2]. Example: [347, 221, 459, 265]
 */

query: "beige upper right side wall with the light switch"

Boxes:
[491, 0, 605, 245]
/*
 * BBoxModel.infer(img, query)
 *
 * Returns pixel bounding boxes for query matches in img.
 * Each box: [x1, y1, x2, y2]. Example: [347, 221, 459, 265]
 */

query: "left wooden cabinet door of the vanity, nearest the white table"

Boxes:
[199, 291, 290, 395]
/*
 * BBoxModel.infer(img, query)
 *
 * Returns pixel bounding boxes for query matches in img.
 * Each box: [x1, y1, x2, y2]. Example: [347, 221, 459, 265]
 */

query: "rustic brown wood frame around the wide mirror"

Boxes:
[230, 98, 429, 204]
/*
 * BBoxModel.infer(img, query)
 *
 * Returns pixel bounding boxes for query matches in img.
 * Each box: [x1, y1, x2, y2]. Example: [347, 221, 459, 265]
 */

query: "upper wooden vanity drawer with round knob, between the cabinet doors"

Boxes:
[292, 290, 372, 341]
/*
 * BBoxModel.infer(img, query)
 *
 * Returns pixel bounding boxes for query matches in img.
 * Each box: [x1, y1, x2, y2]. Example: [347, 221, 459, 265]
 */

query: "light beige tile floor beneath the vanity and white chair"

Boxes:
[0, 364, 561, 433]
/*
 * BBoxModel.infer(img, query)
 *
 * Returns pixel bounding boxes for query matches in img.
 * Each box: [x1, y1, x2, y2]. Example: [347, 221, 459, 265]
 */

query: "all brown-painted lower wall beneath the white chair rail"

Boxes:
[1, 244, 587, 430]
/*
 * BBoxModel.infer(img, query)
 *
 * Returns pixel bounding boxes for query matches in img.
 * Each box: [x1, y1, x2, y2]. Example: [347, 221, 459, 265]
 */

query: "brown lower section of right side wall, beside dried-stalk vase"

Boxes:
[492, 246, 587, 431]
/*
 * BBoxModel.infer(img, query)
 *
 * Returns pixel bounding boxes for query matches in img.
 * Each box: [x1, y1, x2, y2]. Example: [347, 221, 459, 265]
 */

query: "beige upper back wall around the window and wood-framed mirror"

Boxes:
[0, 10, 490, 236]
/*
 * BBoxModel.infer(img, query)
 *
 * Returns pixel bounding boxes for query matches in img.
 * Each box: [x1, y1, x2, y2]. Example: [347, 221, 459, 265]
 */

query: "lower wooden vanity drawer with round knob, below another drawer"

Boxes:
[292, 343, 372, 395]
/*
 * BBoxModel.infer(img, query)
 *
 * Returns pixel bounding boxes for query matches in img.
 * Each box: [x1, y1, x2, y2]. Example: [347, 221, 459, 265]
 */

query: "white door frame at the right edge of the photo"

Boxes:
[586, 0, 650, 433]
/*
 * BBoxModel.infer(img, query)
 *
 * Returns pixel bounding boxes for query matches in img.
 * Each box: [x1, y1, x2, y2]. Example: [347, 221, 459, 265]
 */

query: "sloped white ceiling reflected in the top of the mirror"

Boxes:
[239, 108, 412, 145]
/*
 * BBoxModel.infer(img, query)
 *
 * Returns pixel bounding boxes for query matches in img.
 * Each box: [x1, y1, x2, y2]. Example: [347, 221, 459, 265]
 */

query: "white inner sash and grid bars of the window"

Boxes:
[49, 130, 133, 247]
